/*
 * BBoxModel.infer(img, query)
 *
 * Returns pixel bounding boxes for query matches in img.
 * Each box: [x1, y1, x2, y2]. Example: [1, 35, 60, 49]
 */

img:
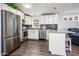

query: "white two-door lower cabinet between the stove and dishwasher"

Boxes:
[28, 29, 39, 40]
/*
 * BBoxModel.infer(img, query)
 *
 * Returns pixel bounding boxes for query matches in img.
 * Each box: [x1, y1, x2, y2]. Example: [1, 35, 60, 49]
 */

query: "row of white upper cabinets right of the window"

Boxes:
[40, 15, 58, 24]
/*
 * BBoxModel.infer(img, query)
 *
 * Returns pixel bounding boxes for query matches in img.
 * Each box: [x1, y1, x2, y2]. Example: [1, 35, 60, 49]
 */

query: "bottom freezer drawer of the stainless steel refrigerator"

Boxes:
[2, 36, 21, 55]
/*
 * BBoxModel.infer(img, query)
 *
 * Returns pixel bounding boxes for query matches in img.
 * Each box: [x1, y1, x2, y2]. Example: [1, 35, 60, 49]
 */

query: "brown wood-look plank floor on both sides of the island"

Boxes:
[9, 40, 79, 56]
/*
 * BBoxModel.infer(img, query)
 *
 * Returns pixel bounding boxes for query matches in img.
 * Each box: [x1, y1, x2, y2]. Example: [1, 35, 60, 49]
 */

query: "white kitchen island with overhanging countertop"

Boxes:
[48, 30, 74, 55]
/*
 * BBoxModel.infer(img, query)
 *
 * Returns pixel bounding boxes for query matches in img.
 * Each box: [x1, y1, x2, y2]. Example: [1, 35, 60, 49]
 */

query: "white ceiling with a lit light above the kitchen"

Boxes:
[16, 3, 79, 16]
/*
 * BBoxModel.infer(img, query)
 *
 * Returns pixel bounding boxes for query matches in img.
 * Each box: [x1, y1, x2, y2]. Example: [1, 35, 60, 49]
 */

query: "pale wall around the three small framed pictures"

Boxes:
[58, 10, 79, 30]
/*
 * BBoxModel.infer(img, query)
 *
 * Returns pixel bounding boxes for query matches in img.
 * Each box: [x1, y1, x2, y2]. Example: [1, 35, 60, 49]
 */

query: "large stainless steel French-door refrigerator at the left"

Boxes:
[1, 10, 21, 55]
